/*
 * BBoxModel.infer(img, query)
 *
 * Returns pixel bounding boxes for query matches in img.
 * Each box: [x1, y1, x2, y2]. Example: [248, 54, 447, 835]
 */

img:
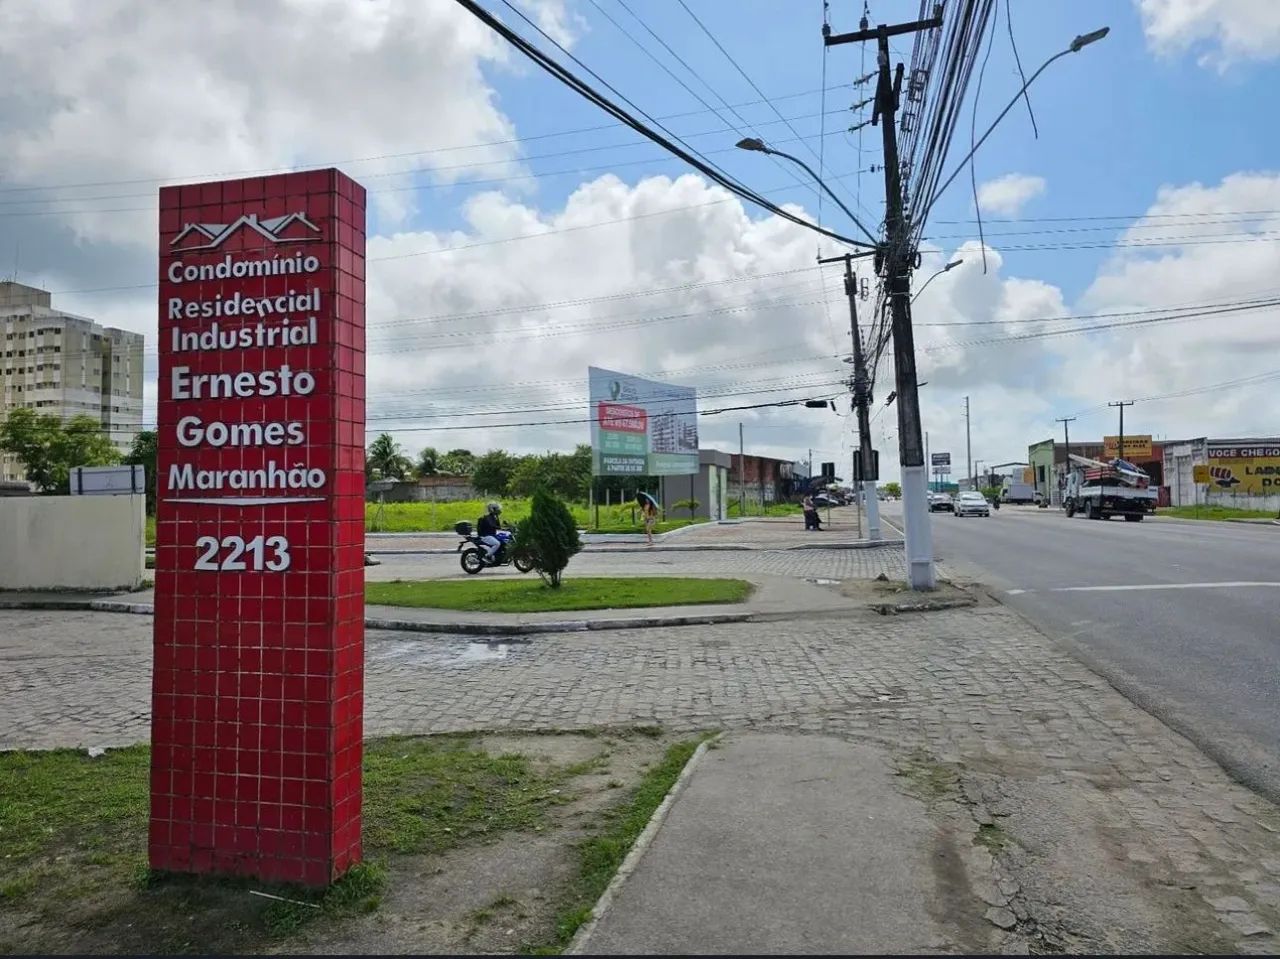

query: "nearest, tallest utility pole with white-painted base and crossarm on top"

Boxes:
[823, 11, 942, 589]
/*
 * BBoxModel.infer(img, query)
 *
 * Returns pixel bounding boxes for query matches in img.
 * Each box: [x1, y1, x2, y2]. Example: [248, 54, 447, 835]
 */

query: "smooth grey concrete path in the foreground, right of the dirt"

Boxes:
[572, 732, 988, 955]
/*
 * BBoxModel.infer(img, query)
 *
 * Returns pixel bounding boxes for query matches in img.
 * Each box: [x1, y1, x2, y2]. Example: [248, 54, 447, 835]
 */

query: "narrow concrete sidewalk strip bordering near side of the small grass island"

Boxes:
[0, 575, 858, 635]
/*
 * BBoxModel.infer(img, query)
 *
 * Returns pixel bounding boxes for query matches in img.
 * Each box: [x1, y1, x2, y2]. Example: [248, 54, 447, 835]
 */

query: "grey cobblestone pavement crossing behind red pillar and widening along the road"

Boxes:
[0, 604, 1280, 953]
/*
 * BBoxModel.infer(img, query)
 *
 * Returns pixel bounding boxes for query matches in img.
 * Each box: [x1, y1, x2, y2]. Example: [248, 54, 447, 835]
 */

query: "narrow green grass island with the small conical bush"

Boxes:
[365, 576, 753, 613]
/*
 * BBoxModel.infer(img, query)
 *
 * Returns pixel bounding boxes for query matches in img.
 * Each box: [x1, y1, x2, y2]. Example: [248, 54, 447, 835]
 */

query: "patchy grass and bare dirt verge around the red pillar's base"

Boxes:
[0, 729, 673, 954]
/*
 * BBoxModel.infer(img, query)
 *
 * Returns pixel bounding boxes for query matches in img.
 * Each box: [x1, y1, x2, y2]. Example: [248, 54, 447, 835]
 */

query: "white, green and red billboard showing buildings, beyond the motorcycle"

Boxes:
[586, 366, 698, 476]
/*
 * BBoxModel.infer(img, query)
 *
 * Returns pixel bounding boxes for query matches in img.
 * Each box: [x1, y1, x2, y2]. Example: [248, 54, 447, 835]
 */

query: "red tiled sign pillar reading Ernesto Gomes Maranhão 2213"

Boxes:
[150, 170, 365, 885]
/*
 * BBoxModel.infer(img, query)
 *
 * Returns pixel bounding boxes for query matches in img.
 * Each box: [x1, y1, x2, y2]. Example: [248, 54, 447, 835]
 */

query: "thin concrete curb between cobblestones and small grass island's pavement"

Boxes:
[0, 599, 762, 636]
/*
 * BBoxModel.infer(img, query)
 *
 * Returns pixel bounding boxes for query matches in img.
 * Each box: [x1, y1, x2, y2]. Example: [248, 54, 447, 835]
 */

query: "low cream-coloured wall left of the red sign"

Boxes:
[0, 496, 146, 589]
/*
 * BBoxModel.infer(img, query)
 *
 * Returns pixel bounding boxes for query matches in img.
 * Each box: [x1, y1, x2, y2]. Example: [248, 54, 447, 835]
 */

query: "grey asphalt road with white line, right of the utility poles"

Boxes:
[886, 503, 1280, 802]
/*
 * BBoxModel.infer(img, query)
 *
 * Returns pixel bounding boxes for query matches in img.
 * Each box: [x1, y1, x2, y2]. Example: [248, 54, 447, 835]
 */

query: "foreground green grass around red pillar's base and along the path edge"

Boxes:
[0, 729, 696, 954]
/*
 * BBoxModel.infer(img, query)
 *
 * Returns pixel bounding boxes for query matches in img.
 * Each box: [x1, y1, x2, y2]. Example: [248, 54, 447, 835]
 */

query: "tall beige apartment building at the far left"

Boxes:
[0, 280, 143, 481]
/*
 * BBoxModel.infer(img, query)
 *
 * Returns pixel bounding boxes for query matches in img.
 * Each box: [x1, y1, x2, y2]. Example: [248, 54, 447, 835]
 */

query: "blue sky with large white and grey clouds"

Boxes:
[0, 0, 1280, 479]
